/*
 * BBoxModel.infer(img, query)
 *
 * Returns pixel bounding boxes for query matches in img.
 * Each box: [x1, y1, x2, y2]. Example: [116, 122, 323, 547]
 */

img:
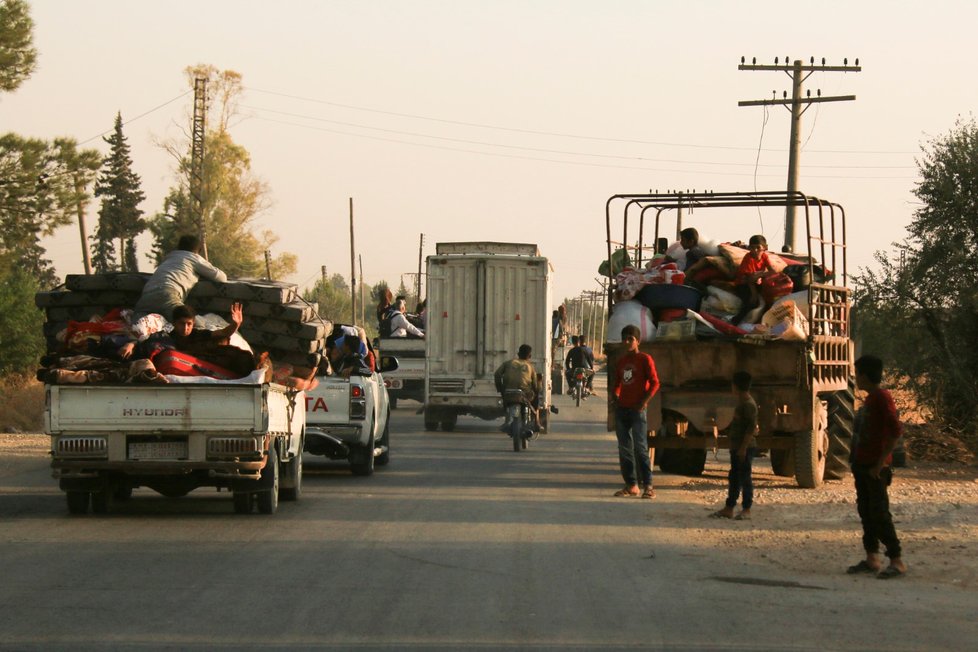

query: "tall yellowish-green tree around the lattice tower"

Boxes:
[150, 65, 297, 278]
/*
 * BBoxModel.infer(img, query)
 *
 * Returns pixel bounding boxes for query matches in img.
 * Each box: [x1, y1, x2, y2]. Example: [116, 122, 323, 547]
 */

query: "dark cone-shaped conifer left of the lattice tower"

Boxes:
[92, 113, 146, 272]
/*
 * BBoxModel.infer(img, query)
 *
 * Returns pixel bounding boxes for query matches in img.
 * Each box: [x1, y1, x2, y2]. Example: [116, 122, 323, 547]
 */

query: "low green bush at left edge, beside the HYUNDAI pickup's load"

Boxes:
[0, 261, 45, 375]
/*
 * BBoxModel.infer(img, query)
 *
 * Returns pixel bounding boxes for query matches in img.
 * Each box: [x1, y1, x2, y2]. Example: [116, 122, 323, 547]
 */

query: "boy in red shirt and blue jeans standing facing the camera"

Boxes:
[609, 325, 659, 498]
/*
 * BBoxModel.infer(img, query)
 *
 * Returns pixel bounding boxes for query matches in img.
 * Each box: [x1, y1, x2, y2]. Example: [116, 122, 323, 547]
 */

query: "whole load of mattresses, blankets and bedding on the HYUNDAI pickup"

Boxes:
[35, 273, 332, 389]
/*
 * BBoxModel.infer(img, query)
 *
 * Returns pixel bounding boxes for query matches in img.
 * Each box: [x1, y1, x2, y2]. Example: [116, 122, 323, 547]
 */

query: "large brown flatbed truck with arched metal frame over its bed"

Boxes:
[605, 192, 854, 488]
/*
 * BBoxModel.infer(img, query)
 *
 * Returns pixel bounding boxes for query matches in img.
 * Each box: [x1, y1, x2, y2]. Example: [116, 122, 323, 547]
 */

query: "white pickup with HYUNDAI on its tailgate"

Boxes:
[45, 382, 305, 514]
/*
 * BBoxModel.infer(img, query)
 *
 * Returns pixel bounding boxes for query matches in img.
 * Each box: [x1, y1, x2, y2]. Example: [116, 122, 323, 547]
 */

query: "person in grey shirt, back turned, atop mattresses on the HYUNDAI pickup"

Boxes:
[133, 235, 228, 322]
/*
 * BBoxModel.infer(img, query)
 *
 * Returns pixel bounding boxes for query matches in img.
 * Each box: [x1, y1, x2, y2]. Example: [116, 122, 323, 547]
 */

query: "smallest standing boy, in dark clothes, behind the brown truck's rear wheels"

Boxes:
[712, 371, 757, 521]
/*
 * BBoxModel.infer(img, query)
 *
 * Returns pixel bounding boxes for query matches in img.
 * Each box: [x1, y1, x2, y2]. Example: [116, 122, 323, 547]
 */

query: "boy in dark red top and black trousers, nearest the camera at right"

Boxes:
[846, 355, 907, 580]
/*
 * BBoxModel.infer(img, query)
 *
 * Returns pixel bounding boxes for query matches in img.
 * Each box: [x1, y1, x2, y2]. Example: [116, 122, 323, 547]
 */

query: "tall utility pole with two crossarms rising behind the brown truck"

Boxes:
[737, 57, 862, 251]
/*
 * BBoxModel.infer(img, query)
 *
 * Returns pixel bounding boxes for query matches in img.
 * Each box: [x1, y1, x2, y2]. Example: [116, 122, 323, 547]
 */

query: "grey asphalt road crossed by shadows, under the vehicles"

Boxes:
[0, 390, 978, 650]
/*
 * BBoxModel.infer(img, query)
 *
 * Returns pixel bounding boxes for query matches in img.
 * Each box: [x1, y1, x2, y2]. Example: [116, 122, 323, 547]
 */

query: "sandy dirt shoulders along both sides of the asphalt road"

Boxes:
[7, 434, 978, 591]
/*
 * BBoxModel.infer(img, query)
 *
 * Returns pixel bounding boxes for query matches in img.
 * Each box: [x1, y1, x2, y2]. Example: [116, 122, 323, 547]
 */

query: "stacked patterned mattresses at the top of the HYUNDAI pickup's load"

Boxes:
[34, 272, 333, 367]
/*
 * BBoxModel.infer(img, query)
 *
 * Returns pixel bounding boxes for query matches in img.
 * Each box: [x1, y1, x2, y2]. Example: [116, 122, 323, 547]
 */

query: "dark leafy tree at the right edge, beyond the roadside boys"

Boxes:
[853, 120, 978, 433]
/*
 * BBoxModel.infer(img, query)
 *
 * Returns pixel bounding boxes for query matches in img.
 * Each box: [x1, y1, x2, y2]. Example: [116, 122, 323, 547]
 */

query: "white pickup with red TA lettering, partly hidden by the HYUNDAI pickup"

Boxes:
[305, 342, 398, 475]
